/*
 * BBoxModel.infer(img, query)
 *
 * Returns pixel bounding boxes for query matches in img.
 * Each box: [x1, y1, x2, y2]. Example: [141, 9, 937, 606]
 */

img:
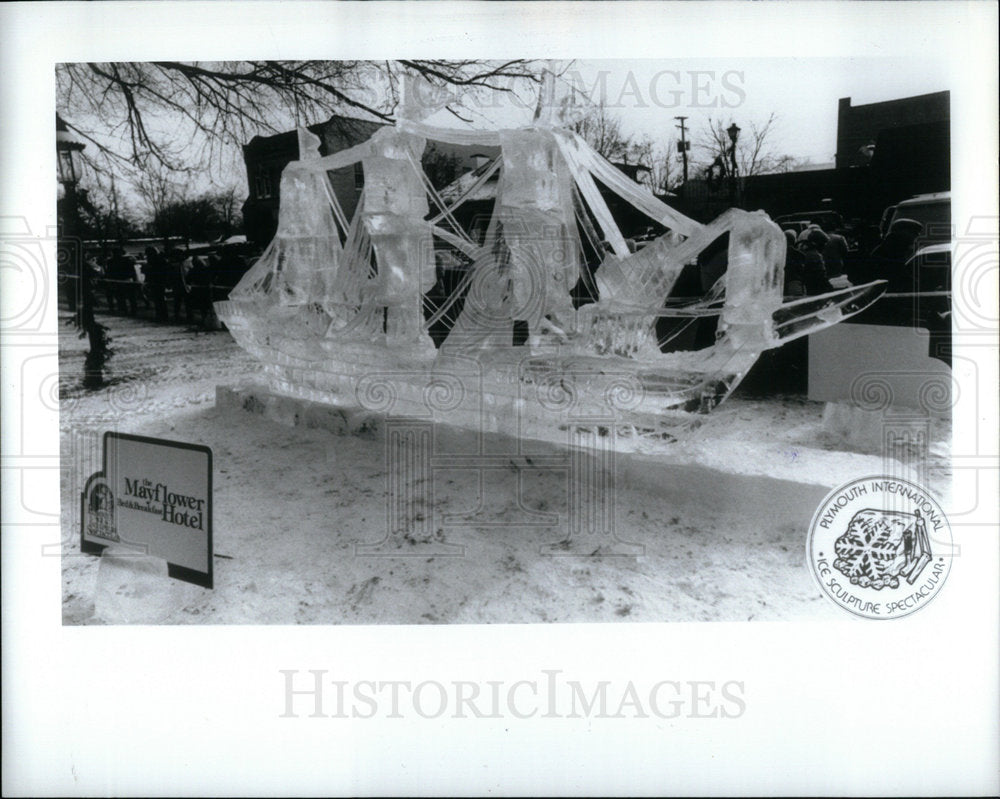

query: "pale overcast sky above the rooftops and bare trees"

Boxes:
[64, 57, 951, 214]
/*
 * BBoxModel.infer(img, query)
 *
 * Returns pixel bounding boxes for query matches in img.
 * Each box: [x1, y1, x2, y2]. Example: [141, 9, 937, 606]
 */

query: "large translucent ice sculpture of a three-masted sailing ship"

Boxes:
[216, 77, 883, 441]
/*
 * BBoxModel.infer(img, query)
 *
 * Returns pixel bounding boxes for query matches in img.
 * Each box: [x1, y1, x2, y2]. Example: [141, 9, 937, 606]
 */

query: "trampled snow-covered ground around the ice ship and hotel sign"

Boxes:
[59, 312, 950, 624]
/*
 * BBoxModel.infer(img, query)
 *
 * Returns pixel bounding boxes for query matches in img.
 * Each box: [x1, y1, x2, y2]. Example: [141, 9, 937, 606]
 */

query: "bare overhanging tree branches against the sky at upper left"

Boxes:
[56, 60, 540, 177]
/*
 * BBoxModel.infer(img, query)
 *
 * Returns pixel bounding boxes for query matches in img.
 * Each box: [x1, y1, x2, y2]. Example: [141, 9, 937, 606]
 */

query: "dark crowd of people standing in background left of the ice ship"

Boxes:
[71, 244, 255, 326]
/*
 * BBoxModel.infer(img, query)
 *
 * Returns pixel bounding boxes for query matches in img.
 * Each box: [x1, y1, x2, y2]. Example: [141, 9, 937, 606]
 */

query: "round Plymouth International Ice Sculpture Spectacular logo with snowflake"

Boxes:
[806, 477, 953, 619]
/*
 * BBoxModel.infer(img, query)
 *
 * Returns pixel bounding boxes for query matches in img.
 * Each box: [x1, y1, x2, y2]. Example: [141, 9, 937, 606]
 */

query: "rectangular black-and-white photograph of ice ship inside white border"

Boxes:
[56, 59, 952, 624]
